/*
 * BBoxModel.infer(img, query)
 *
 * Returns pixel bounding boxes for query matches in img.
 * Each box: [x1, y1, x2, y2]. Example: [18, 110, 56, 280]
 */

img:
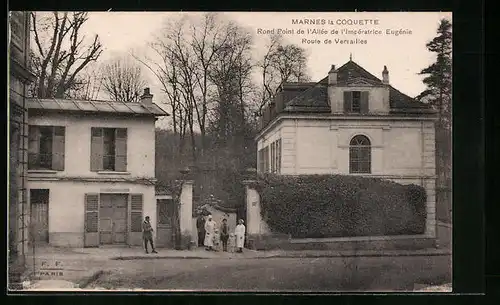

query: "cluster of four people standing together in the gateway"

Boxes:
[196, 213, 245, 253]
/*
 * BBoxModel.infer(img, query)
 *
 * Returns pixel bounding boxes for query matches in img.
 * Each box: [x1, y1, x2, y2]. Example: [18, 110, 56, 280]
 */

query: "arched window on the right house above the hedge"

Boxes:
[349, 135, 371, 174]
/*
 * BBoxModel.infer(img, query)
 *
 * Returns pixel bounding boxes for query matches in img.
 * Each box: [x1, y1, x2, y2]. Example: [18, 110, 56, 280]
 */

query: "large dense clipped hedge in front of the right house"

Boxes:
[255, 175, 427, 238]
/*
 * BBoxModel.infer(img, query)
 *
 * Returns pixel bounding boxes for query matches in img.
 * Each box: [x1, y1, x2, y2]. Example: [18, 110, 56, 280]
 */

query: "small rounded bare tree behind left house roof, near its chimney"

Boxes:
[101, 56, 146, 103]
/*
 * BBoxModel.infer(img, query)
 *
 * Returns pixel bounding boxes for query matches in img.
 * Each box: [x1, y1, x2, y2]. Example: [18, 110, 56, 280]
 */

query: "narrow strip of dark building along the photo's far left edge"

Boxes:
[7, 11, 34, 283]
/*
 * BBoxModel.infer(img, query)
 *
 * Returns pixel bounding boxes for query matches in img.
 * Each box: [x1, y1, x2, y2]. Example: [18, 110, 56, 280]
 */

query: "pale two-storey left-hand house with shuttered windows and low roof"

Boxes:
[28, 89, 167, 247]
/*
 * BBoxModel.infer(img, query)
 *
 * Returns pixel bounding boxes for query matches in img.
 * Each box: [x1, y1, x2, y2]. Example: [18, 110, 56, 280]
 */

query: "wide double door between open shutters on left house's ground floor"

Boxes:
[99, 194, 128, 245]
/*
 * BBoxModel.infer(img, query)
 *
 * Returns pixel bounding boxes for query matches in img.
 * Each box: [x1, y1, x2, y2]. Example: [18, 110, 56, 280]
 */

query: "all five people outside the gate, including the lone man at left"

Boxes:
[142, 213, 245, 253]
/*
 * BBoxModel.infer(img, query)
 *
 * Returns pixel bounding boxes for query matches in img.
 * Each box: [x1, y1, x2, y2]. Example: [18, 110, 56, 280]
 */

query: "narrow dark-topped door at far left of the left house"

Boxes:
[30, 189, 49, 244]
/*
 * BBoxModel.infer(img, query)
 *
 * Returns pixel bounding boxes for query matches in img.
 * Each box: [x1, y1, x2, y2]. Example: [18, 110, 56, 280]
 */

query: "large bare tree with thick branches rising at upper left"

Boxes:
[31, 12, 102, 98]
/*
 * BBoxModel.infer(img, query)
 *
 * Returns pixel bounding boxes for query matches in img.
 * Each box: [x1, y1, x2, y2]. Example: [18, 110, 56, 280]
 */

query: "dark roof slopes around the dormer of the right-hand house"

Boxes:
[283, 60, 430, 113]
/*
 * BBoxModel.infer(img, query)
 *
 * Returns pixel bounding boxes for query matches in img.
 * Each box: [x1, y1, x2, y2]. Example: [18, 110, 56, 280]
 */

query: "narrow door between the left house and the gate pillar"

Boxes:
[156, 199, 175, 248]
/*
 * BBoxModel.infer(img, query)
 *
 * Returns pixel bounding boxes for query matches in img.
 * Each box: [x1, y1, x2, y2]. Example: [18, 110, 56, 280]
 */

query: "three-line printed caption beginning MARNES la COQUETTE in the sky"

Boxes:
[257, 18, 413, 44]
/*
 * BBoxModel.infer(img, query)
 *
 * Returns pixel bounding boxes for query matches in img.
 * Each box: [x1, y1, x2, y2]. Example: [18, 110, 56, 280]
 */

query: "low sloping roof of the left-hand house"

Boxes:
[27, 98, 169, 116]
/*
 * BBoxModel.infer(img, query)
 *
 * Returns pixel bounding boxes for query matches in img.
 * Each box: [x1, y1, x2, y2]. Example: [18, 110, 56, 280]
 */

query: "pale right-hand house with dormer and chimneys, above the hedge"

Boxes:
[257, 60, 436, 237]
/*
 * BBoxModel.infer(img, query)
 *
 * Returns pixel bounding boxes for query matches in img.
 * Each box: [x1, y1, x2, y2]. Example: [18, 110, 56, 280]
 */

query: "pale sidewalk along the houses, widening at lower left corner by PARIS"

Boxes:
[22, 246, 450, 290]
